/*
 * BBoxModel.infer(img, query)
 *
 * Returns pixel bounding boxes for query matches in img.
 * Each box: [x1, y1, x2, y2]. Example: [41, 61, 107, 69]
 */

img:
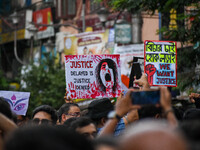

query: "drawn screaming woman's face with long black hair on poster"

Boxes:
[95, 58, 118, 97]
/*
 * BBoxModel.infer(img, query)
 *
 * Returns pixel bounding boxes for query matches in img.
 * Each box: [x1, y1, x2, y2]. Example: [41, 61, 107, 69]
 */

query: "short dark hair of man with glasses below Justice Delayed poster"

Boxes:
[58, 103, 79, 122]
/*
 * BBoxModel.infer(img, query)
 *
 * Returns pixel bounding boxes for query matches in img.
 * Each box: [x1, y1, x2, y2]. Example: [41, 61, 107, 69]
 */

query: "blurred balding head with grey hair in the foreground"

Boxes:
[119, 120, 188, 150]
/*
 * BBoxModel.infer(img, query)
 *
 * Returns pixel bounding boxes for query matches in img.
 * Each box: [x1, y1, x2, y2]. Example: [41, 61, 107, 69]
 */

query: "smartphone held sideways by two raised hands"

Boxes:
[131, 90, 160, 105]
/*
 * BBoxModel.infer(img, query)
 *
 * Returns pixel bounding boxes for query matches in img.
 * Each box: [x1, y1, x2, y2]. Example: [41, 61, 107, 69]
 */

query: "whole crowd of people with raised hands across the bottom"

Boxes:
[0, 74, 200, 150]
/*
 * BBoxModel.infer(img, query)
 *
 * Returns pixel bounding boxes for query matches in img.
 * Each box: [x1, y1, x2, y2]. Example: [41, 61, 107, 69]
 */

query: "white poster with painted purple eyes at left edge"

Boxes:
[0, 91, 30, 116]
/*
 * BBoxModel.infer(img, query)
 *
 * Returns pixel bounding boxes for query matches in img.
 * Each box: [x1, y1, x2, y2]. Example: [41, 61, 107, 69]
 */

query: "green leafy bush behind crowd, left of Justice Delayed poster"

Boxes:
[21, 56, 65, 116]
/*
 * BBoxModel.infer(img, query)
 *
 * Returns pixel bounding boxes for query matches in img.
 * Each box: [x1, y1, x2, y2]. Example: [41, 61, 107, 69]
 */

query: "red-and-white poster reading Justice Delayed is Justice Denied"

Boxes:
[65, 55, 121, 99]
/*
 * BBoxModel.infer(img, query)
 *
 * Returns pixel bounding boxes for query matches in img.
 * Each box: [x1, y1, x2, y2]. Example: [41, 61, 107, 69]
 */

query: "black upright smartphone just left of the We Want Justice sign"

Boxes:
[129, 62, 142, 88]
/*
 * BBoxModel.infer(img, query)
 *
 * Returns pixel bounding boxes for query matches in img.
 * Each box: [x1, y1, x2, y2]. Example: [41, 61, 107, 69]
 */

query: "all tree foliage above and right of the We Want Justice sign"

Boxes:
[103, 0, 200, 90]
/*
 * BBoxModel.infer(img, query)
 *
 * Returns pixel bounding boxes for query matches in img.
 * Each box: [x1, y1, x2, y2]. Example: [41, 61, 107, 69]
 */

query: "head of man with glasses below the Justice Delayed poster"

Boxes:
[58, 103, 81, 124]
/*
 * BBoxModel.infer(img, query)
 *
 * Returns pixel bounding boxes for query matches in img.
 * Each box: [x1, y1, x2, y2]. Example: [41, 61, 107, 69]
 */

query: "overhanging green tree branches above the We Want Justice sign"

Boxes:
[105, 0, 200, 44]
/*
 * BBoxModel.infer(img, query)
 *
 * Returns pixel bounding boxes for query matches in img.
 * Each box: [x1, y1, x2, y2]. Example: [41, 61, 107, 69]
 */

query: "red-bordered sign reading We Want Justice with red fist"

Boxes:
[144, 40, 177, 87]
